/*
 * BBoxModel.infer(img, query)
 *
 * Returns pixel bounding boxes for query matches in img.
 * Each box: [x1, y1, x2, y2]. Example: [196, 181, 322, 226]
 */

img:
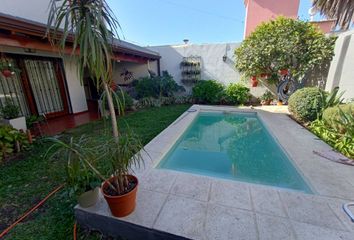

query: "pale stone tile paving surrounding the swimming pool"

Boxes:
[75, 105, 354, 239]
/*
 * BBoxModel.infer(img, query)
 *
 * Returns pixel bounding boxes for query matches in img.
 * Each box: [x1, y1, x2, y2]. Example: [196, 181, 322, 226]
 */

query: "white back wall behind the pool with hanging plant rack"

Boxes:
[149, 43, 264, 97]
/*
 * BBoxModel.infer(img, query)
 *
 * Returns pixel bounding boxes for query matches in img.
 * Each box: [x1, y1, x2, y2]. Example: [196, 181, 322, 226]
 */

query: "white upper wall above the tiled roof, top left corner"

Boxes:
[0, 0, 50, 24]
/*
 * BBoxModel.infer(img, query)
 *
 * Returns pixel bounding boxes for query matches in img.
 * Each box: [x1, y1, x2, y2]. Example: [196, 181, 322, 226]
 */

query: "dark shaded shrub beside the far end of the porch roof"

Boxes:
[133, 71, 185, 99]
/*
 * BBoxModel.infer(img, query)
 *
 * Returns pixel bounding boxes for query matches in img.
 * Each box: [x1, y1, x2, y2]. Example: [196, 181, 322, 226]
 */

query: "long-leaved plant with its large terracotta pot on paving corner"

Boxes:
[102, 132, 143, 217]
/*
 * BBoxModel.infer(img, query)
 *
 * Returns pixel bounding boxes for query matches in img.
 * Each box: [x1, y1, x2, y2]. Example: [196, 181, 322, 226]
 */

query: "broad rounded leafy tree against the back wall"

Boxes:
[235, 17, 335, 84]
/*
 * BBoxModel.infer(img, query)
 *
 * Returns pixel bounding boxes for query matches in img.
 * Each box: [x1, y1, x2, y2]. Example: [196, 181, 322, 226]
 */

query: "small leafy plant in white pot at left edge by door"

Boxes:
[0, 98, 27, 131]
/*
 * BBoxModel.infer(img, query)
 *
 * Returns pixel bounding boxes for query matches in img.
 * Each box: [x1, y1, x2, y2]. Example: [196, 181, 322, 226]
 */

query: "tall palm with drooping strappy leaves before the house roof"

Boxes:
[47, 0, 120, 140]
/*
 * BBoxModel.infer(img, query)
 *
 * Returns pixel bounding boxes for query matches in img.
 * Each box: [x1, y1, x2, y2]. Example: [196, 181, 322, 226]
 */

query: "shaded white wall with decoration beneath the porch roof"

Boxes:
[113, 61, 158, 84]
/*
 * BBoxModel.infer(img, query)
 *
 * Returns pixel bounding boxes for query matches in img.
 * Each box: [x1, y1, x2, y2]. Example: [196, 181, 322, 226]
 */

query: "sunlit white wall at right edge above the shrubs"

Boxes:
[326, 30, 354, 100]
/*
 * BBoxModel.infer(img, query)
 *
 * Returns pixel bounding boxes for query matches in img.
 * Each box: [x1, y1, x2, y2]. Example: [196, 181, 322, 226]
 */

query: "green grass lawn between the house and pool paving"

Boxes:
[0, 105, 189, 240]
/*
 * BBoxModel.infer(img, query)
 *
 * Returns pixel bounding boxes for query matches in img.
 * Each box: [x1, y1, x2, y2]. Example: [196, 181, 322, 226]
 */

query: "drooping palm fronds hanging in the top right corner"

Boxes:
[312, 0, 354, 30]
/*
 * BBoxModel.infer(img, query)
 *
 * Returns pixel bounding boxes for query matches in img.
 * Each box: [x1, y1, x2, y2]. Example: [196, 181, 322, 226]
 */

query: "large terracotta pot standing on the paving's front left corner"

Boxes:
[102, 175, 138, 217]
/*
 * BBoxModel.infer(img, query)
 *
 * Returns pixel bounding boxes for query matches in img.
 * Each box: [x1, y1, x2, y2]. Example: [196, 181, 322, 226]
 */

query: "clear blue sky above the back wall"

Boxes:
[107, 0, 320, 46]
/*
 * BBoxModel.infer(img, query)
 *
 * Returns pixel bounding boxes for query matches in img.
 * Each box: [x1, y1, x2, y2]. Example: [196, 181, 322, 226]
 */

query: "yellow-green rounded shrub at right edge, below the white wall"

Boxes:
[322, 103, 354, 134]
